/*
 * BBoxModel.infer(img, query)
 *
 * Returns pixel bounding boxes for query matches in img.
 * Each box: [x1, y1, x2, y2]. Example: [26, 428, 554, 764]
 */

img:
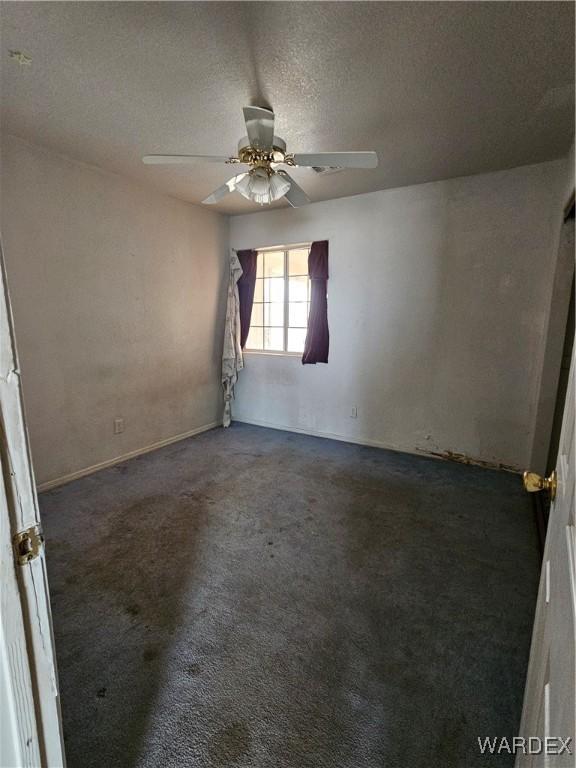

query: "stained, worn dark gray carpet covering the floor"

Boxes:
[41, 424, 539, 768]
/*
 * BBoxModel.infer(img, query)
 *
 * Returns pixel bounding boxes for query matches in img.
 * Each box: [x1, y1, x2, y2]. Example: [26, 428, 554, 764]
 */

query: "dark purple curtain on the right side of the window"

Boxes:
[302, 240, 330, 365]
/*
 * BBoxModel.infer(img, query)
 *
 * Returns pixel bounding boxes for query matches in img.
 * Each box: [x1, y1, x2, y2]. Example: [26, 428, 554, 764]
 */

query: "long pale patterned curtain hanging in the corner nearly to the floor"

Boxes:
[222, 251, 244, 427]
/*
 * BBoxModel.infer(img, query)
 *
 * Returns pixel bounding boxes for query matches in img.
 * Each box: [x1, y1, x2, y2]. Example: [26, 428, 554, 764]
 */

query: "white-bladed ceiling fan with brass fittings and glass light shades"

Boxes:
[142, 107, 378, 208]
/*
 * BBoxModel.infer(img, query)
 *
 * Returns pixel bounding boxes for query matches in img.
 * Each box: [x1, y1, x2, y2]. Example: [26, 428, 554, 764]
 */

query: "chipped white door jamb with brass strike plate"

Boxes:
[0, 240, 65, 768]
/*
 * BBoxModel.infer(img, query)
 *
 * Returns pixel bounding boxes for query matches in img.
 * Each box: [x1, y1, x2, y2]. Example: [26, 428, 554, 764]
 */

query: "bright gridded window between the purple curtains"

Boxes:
[246, 245, 310, 353]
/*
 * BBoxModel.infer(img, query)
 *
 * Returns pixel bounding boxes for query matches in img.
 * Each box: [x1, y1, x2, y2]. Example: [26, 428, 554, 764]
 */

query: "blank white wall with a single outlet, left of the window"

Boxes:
[1, 137, 228, 483]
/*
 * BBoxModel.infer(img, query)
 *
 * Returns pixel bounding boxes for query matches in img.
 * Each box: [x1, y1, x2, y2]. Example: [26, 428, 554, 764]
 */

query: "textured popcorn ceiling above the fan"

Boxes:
[0, 2, 574, 213]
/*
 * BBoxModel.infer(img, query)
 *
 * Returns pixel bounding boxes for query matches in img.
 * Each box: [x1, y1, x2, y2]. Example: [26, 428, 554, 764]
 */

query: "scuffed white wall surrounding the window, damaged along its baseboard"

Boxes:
[230, 161, 565, 469]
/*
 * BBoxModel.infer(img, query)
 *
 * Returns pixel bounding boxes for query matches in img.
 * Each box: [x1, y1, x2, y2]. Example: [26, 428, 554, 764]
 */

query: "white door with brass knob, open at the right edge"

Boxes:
[516, 354, 576, 768]
